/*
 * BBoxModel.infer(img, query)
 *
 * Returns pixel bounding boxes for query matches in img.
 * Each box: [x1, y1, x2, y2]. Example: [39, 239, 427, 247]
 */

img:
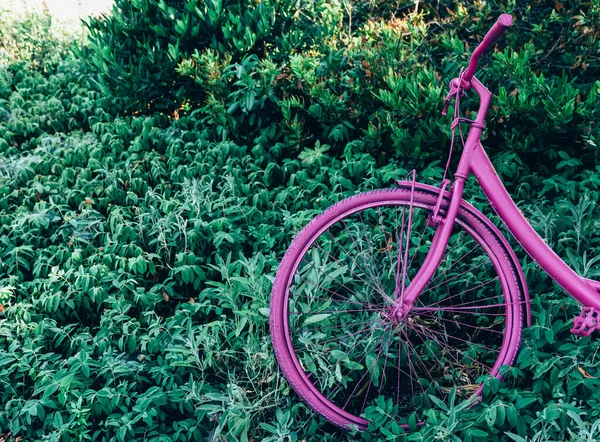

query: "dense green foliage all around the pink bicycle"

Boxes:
[0, 0, 600, 442]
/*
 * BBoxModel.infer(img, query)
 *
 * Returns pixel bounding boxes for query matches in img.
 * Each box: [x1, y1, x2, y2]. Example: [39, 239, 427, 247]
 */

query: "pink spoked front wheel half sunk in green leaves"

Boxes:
[270, 189, 522, 430]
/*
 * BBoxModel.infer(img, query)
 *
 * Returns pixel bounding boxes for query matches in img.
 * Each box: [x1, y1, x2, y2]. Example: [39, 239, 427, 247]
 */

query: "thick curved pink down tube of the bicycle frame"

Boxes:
[470, 143, 600, 309]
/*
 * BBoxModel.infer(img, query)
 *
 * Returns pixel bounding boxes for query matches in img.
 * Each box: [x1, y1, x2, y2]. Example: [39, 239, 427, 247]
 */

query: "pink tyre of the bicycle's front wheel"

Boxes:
[270, 189, 523, 430]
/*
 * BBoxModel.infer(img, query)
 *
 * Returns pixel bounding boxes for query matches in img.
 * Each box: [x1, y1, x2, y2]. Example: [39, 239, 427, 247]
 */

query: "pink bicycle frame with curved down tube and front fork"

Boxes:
[395, 77, 600, 318]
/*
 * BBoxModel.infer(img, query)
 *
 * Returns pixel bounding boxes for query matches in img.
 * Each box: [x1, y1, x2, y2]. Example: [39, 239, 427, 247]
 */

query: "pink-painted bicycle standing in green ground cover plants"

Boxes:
[271, 14, 600, 430]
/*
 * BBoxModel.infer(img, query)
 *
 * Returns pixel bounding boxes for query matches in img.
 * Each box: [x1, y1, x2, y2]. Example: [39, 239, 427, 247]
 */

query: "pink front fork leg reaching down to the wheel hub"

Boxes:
[392, 176, 465, 320]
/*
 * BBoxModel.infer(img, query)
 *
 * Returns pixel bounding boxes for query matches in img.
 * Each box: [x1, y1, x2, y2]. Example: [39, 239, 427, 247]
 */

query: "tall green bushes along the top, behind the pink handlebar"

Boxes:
[81, 0, 600, 169]
